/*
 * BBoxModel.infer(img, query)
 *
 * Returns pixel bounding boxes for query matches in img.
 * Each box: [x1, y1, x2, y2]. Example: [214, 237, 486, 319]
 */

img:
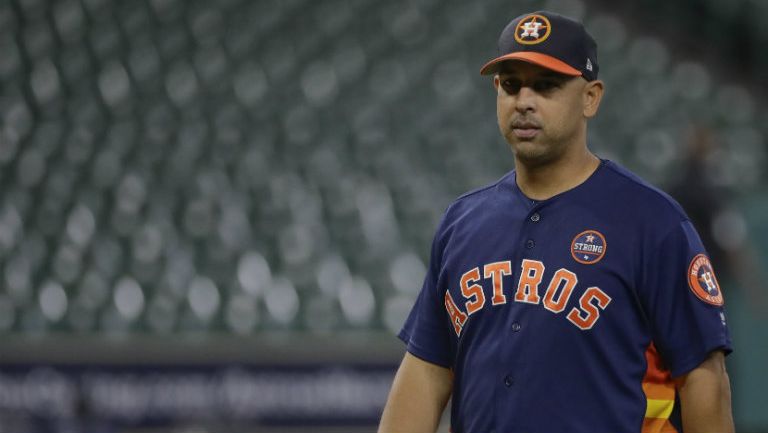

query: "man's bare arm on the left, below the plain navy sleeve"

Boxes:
[379, 352, 453, 433]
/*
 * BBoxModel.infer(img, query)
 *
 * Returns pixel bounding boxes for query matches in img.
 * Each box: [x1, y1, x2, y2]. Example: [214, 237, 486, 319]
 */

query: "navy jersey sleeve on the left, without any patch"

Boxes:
[398, 219, 452, 368]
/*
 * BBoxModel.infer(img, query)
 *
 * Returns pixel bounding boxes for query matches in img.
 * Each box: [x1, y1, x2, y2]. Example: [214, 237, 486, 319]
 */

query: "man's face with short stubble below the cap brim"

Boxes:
[494, 61, 594, 166]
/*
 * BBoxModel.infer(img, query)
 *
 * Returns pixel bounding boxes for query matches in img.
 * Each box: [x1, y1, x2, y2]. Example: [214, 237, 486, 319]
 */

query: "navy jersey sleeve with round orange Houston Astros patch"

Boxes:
[640, 220, 732, 377]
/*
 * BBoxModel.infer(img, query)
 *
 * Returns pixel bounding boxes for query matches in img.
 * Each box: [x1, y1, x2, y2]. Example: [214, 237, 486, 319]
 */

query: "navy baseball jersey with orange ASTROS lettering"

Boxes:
[399, 160, 731, 433]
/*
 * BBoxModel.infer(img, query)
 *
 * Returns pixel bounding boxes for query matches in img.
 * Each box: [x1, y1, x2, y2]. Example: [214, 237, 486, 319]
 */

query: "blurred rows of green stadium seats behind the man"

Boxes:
[0, 0, 768, 430]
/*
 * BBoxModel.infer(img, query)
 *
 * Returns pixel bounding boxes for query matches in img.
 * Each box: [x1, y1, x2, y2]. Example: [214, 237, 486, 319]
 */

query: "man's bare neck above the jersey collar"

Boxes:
[515, 148, 600, 200]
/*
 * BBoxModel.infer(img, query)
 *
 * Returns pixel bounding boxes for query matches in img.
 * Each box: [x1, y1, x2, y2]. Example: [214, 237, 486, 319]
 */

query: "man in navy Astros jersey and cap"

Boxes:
[379, 12, 733, 433]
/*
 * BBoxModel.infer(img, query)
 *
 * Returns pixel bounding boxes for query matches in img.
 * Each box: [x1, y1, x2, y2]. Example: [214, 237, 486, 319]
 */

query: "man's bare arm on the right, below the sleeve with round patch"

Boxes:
[678, 350, 734, 433]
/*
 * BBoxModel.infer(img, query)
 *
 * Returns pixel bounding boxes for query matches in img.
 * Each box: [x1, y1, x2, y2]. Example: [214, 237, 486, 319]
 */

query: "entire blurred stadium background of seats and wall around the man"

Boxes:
[0, 0, 768, 433]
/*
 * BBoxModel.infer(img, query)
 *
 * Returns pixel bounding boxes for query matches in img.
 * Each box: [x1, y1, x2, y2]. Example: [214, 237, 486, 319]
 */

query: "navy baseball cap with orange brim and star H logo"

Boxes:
[480, 11, 599, 81]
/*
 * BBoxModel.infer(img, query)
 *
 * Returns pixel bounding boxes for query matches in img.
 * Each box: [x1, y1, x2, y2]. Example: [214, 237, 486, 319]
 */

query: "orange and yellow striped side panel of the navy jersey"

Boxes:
[642, 343, 677, 433]
